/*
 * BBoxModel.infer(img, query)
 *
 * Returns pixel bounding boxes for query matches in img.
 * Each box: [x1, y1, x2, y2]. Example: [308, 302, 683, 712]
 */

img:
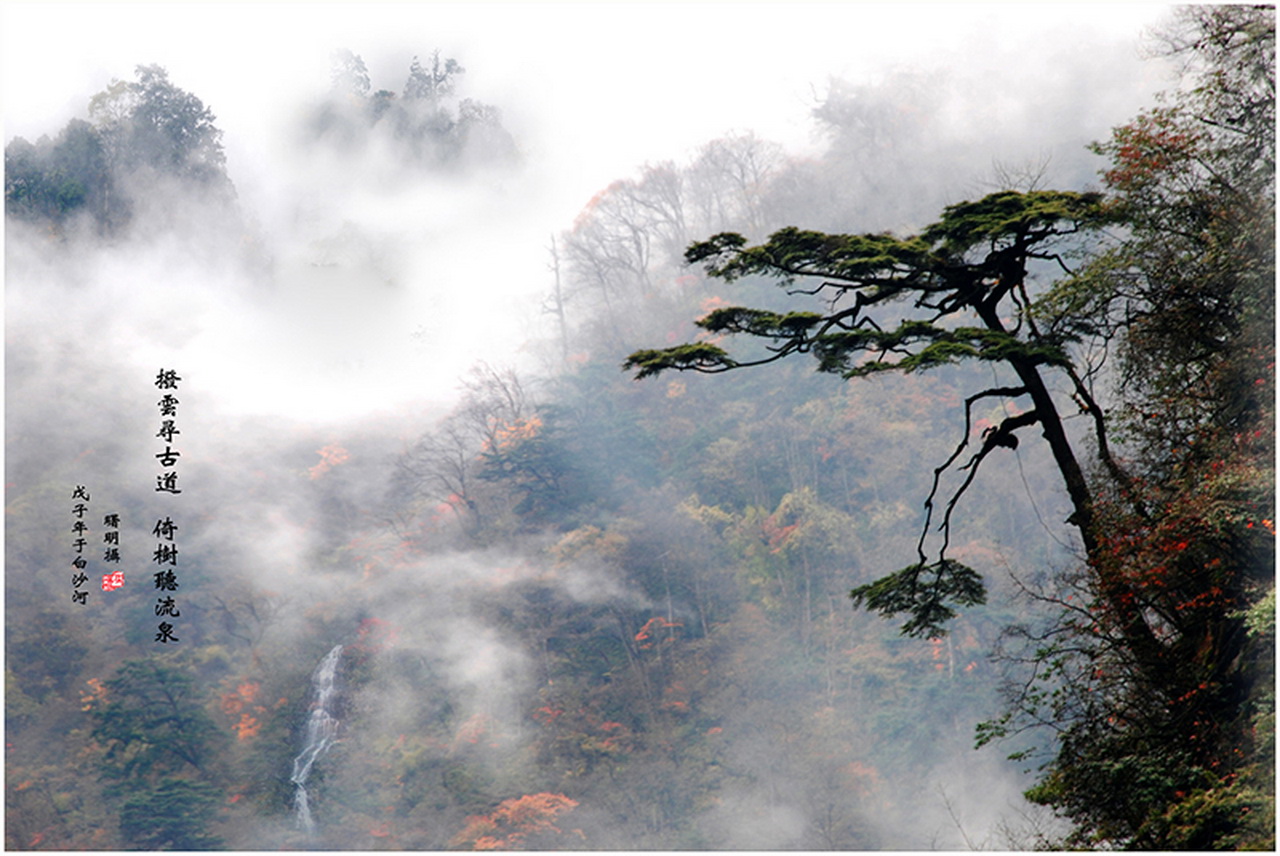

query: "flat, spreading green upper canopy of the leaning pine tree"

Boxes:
[623, 191, 1108, 377]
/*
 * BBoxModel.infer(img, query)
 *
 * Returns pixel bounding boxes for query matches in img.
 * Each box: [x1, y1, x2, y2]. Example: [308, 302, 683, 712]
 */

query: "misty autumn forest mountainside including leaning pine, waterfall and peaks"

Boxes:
[5, 5, 1275, 851]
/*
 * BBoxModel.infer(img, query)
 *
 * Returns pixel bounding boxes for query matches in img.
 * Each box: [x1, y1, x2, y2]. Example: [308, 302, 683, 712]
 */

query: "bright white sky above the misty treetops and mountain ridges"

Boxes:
[0, 3, 1167, 216]
